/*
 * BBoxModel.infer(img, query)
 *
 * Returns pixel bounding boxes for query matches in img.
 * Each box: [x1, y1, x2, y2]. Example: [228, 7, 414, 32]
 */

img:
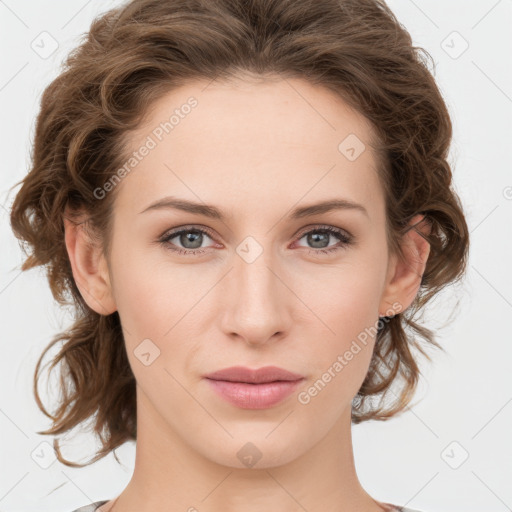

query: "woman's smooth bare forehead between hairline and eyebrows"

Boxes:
[114, 78, 381, 219]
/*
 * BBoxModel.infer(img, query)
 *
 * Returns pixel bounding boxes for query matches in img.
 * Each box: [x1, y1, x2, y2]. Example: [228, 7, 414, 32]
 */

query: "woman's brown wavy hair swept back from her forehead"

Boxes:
[10, 0, 469, 467]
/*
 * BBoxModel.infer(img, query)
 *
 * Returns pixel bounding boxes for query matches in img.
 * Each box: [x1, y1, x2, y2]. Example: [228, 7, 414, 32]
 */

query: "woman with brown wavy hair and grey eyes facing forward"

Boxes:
[11, 0, 469, 512]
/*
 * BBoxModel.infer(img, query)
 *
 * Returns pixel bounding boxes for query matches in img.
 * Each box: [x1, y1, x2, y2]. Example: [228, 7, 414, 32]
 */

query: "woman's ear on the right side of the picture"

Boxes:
[379, 214, 431, 316]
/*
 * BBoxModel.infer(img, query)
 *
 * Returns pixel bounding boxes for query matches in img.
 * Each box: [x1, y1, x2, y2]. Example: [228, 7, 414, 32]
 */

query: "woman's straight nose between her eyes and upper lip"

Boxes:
[219, 241, 297, 346]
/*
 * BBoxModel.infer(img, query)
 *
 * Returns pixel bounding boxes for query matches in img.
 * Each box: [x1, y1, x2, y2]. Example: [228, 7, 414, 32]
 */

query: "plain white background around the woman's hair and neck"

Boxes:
[0, 0, 512, 512]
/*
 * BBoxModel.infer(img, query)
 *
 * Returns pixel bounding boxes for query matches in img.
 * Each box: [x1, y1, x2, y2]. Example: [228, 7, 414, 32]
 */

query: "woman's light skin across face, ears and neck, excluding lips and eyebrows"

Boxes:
[65, 74, 429, 512]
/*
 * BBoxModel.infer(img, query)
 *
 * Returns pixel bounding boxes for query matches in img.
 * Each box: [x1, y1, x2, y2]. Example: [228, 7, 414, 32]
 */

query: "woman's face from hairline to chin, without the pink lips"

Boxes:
[76, 75, 414, 467]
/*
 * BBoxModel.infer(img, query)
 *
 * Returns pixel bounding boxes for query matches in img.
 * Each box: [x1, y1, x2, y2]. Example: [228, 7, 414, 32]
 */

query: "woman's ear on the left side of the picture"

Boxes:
[63, 208, 117, 315]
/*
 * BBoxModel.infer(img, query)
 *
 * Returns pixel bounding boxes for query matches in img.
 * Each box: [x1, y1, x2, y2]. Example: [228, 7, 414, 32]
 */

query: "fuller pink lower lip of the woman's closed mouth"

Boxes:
[206, 378, 304, 409]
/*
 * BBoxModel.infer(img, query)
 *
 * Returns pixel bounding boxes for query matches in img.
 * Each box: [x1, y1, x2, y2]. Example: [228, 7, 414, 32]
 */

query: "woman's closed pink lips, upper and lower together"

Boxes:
[205, 366, 304, 409]
